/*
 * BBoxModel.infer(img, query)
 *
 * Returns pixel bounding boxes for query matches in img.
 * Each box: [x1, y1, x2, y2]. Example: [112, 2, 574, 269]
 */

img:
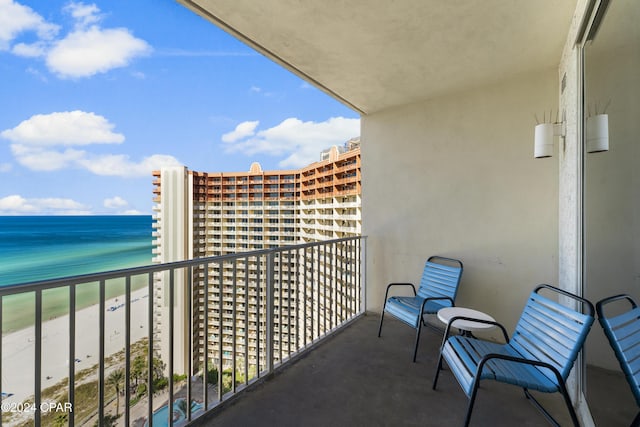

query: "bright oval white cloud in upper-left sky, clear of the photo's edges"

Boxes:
[46, 26, 151, 78]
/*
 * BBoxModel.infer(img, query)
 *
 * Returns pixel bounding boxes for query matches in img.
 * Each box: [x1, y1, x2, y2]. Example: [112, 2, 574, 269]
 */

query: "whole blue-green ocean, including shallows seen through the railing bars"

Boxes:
[0, 216, 153, 332]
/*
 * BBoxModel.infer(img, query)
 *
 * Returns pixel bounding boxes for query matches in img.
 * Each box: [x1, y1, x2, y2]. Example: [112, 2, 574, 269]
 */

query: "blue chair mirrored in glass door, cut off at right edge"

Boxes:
[596, 294, 640, 426]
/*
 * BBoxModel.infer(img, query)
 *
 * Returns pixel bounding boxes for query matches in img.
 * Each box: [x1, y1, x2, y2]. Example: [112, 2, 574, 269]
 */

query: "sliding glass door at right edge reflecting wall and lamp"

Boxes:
[583, 0, 640, 426]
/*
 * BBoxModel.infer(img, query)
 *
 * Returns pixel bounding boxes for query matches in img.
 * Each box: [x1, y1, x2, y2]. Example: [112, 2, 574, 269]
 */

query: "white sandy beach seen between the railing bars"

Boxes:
[2, 289, 149, 402]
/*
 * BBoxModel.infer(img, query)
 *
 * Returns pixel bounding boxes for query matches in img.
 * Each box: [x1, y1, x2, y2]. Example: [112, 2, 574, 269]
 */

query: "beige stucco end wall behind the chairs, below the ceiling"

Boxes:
[362, 69, 558, 336]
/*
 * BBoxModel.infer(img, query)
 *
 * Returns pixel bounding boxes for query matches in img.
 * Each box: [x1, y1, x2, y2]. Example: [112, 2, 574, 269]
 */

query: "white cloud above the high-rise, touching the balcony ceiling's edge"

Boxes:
[222, 117, 360, 168]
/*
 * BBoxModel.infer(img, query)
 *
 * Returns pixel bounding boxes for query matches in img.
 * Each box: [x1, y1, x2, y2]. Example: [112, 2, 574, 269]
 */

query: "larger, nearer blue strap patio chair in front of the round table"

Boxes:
[433, 285, 594, 426]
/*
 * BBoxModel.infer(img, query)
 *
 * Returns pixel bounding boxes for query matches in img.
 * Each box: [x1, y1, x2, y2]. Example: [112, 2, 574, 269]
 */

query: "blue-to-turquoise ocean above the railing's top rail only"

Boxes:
[0, 215, 152, 286]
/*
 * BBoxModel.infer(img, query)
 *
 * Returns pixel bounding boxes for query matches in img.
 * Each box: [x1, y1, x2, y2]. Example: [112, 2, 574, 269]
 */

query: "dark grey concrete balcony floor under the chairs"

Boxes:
[194, 314, 637, 427]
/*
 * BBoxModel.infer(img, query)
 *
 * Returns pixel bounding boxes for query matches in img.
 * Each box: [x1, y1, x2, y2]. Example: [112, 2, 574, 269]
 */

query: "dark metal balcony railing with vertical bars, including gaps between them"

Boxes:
[0, 237, 366, 426]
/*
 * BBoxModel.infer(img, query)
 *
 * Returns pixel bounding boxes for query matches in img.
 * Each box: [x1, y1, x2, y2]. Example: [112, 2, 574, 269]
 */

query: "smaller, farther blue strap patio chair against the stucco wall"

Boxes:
[378, 255, 463, 362]
